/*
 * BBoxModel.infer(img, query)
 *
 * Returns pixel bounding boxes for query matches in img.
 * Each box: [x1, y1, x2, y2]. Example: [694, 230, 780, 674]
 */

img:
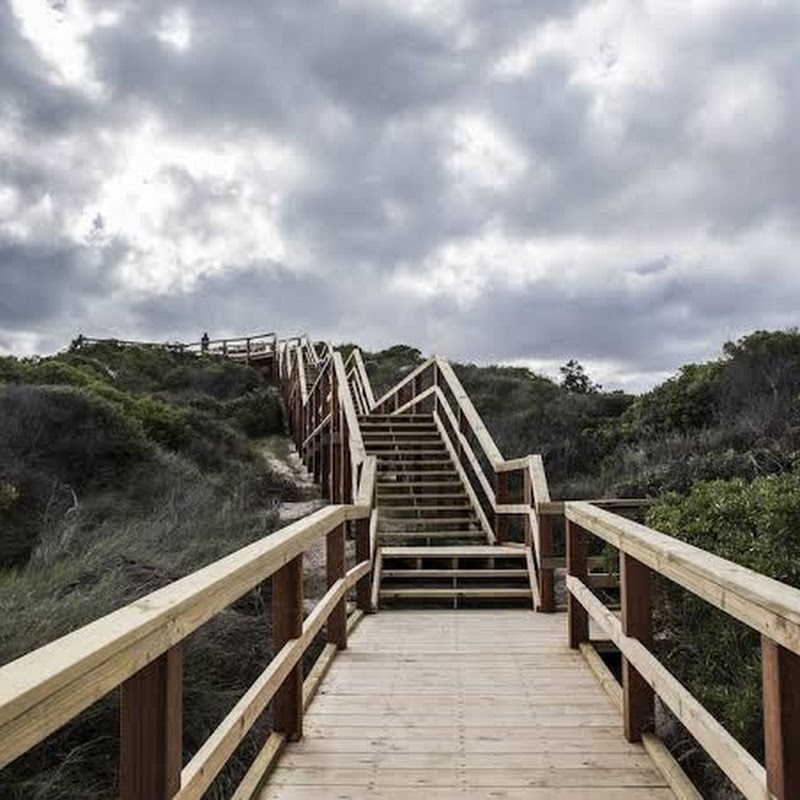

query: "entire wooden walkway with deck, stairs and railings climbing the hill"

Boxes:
[0, 337, 800, 800]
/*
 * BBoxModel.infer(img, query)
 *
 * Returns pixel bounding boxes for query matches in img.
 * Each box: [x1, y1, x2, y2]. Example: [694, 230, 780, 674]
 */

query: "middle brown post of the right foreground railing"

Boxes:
[620, 553, 654, 742]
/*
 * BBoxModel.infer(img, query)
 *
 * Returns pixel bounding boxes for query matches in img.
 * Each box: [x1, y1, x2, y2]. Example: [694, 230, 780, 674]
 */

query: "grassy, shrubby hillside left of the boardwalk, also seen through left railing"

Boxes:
[0, 345, 318, 800]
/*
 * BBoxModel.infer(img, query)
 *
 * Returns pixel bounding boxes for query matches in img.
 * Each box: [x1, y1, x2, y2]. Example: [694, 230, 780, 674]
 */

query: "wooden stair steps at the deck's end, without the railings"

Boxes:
[359, 414, 532, 608]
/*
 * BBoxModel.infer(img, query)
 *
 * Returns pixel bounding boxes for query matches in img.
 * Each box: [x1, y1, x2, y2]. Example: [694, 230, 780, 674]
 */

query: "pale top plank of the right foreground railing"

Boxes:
[566, 502, 800, 654]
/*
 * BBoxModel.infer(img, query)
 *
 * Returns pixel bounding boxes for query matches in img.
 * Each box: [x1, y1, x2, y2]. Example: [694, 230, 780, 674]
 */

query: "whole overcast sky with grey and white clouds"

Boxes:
[0, 0, 800, 388]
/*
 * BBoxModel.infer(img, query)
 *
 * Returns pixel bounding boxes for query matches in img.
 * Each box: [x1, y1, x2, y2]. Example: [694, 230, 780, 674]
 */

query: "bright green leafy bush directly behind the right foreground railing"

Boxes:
[647, 474, 800, 758]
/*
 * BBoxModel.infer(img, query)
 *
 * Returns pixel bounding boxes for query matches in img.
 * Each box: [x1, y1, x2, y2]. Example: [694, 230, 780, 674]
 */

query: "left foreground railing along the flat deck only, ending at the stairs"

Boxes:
[0, 506, 371, 800]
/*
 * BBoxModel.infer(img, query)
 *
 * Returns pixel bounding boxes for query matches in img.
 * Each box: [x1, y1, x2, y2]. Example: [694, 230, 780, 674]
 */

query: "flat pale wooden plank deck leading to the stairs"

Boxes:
[260, 610, 674, 800]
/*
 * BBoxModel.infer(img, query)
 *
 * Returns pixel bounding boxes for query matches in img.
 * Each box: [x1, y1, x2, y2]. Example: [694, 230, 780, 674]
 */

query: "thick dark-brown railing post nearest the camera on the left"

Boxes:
[119, 644, 183, 800]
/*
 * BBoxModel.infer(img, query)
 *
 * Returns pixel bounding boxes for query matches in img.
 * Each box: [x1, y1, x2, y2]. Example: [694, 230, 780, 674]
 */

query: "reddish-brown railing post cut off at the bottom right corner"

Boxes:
[761, 636, 800, 800]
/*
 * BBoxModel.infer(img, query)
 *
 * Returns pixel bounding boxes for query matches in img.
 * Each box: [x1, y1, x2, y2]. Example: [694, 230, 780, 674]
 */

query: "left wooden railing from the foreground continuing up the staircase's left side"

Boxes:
[0, 337, 376, 800]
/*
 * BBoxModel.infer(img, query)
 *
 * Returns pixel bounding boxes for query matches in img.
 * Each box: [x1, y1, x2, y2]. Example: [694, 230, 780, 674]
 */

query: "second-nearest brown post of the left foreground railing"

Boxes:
[272, 555, 303, 741]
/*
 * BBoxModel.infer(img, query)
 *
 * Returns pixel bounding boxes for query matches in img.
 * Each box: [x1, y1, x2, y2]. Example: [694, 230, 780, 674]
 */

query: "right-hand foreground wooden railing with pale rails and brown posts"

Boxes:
[564, 502, 800, 800]
